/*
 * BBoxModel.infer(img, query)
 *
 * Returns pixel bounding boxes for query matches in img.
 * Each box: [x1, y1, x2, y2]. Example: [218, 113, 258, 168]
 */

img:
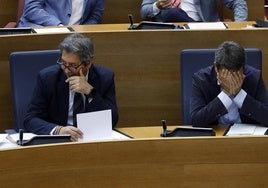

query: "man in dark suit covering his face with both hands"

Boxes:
[190, 41, 268, 127]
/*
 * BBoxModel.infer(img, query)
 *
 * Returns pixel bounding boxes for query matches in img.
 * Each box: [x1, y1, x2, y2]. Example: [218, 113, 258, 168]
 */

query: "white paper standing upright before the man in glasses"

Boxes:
[77, 110, 130, 141]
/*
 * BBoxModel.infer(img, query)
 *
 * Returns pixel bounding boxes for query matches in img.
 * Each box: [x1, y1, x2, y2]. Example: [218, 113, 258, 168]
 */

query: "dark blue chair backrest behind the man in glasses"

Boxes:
[9, 50, 60, 131]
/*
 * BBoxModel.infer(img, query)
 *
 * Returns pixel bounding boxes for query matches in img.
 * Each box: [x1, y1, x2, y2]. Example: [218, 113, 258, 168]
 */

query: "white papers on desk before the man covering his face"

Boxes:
[226, 123, 268, 136]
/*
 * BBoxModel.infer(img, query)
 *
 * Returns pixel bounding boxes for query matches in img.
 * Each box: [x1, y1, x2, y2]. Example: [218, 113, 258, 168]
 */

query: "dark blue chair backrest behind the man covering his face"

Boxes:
[180, 48, 262, 125]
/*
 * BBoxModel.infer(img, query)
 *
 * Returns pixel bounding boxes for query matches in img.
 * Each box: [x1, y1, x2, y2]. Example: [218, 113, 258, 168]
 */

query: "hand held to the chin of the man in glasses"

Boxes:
[65, 69, 93, 95]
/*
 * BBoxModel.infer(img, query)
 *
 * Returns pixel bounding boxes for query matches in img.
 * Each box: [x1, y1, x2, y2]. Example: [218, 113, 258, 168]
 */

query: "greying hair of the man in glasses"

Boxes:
[60, 33, 94, 64]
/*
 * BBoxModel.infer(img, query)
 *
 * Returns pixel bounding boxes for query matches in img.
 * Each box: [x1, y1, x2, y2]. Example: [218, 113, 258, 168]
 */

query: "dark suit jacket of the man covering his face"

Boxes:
[190, 66, 268, 127]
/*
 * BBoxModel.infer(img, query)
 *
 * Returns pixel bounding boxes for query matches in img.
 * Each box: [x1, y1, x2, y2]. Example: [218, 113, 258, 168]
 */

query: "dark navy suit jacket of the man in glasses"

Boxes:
[24, 64, 118, 134]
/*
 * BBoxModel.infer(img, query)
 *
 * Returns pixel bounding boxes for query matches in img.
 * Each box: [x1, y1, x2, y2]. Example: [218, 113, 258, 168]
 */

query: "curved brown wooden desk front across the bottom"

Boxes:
[0, 128, 268, 188]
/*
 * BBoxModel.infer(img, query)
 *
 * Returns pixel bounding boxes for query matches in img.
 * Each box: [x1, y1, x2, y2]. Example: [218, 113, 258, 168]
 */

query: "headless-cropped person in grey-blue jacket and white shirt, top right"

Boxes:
[141, 0, 248, 22]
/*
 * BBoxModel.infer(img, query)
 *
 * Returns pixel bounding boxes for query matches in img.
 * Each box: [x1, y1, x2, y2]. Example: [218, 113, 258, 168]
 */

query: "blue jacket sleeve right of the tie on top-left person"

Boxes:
[81, 0, 104, 24]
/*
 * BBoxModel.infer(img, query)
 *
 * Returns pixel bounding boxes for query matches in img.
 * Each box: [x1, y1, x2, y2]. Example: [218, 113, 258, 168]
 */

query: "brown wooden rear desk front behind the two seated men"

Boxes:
[0, 22, 268, 131]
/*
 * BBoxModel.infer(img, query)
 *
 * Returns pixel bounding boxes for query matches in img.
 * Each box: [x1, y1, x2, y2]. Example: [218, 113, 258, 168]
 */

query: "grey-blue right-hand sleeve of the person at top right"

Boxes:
[222, 0, 248, 21]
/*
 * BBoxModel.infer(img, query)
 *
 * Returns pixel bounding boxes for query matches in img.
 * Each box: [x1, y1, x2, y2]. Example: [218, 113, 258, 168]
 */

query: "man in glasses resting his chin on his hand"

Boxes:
[24, 34, 118, 141]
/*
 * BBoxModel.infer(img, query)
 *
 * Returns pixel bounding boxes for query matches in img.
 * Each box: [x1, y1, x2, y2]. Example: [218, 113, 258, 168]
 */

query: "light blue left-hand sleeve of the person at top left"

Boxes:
[24, 0, 61, 26]
